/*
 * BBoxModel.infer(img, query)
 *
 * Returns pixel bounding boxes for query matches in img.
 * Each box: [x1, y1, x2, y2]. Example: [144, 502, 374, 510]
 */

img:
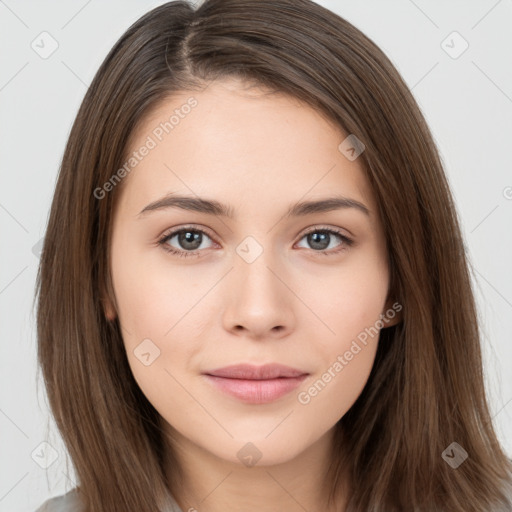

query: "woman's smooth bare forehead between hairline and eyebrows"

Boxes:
[119, 80, 374, 216]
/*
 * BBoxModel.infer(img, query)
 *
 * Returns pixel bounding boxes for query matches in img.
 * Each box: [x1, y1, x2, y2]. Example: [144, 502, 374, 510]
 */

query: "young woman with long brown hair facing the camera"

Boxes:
[38, 0, 512, 512]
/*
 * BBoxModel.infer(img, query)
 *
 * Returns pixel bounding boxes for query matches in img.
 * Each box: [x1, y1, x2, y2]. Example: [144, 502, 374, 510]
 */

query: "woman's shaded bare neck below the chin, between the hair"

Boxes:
[164, 429, 345, 512]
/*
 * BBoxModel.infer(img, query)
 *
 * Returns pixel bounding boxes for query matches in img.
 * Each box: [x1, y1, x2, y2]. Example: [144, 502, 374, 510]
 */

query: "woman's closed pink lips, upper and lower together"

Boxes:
[205, 364, 308, 404]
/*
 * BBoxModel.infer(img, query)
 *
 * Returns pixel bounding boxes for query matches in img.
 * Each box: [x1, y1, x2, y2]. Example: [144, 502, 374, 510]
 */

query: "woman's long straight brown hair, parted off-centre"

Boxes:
[37, 0, 512, 512]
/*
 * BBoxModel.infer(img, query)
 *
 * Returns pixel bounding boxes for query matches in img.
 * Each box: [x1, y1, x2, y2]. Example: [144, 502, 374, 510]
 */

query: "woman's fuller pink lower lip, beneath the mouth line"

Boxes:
[205, 375, 307, 404]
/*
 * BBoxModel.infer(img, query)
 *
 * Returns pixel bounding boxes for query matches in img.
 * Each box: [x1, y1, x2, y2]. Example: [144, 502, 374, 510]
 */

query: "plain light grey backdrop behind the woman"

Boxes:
[0, 0, 512, 512]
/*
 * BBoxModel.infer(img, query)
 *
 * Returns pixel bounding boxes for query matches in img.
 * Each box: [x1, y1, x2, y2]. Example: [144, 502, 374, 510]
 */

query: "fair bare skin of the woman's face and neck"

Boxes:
[106, 80, 398, 512]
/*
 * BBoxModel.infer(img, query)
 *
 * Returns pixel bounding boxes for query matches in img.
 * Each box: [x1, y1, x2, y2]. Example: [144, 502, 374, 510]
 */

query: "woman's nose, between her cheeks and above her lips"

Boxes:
[222, 247, 298, 339]
